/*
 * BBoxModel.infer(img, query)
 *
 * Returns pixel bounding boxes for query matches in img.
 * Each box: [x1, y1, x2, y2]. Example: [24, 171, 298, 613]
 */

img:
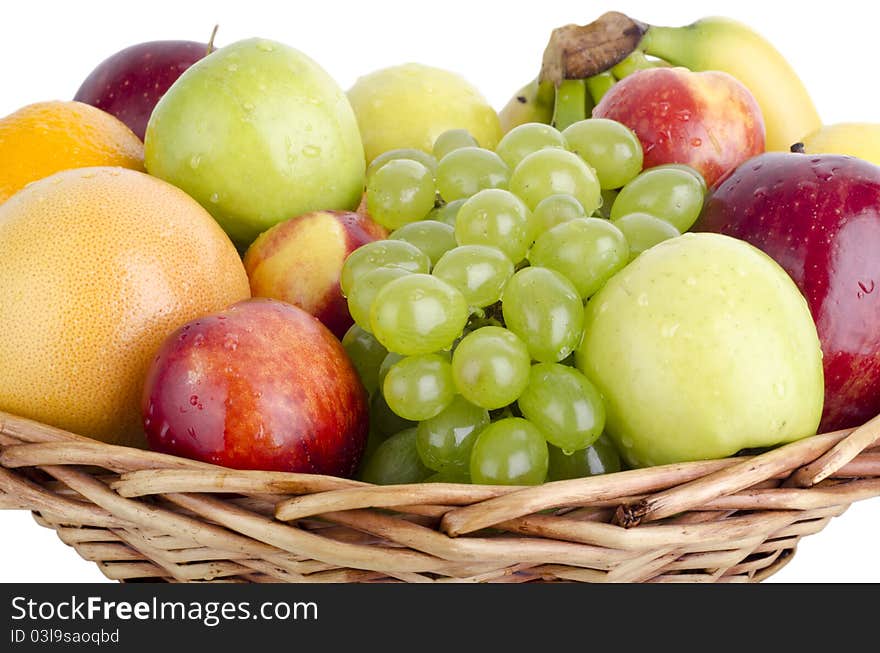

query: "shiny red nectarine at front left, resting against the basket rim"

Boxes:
[142, 299, 369, 477]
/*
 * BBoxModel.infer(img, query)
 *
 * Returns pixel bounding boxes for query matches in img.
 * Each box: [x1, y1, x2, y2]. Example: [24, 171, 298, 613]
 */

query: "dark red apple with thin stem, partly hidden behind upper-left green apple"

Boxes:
[73, 41, 211, 140]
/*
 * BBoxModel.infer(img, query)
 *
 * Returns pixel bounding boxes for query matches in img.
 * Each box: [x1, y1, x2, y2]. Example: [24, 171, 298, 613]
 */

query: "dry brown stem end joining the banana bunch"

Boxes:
[540, 11, 648, 87]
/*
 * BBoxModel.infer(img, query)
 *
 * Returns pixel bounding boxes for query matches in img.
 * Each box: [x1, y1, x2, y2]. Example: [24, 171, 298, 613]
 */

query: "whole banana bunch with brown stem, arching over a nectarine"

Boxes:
[501, 12, 822, 151]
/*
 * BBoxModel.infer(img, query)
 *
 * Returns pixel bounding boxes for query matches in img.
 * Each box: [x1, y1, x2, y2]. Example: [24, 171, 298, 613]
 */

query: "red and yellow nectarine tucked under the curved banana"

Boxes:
[593, 68, 764, 186]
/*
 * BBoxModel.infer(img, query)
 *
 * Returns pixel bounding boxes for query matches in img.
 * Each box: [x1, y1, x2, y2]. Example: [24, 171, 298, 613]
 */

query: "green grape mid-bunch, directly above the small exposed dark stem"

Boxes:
[432, 245, 513, 308]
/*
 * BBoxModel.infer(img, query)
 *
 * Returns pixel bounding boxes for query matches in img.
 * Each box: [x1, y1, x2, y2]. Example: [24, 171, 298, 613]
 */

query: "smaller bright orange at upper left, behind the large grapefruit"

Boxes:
[0, 101, 144, 203]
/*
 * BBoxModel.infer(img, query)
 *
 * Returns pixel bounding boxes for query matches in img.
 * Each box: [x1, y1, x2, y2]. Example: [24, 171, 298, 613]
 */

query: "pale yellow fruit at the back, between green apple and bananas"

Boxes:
[348, 63, 501, 162]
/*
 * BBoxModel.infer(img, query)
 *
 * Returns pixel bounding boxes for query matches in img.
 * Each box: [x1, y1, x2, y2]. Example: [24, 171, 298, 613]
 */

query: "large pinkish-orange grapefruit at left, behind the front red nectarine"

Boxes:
[0, 167, 250, 446]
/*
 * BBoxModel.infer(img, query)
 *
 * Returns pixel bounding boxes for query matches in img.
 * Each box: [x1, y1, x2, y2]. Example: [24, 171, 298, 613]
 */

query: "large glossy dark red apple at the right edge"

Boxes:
[693, 153, 880, 431]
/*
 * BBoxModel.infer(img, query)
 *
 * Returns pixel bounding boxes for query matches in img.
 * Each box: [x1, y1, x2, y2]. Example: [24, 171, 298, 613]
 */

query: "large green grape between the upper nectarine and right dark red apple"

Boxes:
[611, 167, 705, 233]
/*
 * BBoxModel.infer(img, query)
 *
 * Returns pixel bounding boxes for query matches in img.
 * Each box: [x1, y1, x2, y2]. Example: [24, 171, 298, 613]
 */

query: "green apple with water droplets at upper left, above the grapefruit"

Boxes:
[144, 39, 366, 247]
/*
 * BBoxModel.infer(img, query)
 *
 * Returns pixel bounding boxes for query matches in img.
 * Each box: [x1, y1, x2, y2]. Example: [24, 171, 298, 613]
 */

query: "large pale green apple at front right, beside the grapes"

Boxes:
[575, 233, 824, 467]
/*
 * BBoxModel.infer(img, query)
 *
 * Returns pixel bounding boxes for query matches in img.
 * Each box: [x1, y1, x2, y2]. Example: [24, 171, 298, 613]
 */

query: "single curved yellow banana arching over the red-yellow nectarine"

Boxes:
[639, 17, 822, 151]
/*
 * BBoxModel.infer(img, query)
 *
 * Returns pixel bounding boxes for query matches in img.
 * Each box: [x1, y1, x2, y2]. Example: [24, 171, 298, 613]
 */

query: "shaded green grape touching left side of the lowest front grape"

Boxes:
[416, 395, 489, 472]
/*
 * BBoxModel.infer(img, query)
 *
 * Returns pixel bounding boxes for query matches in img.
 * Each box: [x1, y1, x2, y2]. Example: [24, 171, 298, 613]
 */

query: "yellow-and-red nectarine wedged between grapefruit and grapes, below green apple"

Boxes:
[244, 211, 388, 339]
